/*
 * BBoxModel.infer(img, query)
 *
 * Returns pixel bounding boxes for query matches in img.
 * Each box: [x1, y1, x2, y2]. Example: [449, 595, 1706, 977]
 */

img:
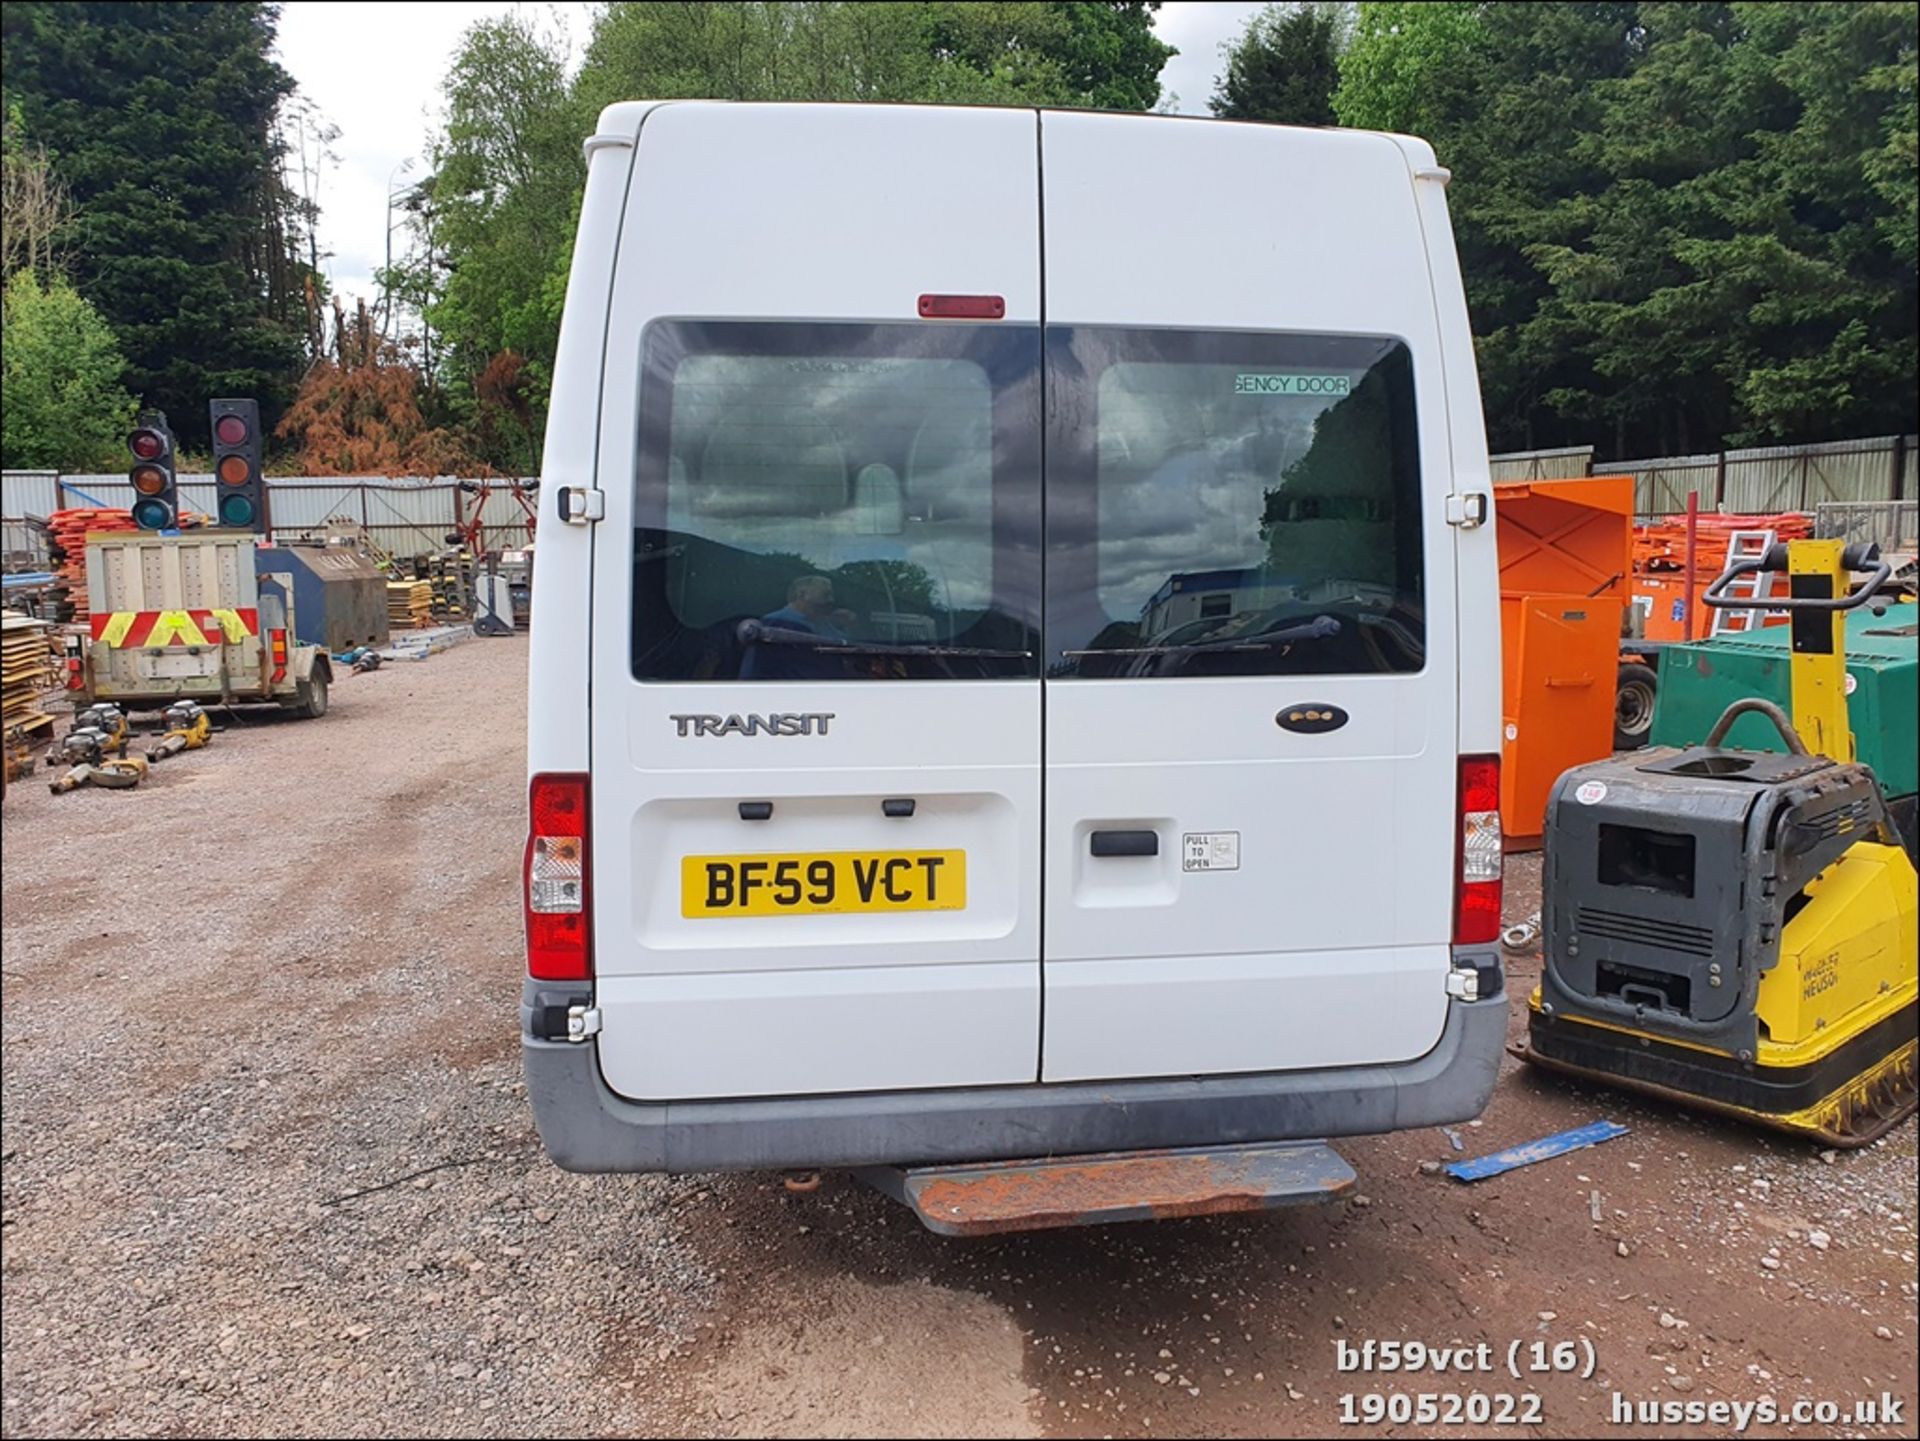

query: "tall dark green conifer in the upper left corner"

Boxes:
[0, 0, 311, 443]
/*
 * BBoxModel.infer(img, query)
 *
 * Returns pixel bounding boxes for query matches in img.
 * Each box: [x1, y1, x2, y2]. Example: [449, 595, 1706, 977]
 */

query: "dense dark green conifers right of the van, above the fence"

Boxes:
[1334, 0, 1920, 457]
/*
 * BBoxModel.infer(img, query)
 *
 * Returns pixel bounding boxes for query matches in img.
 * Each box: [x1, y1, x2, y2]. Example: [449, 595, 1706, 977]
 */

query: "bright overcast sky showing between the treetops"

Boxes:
[280, 0, 1260, 299]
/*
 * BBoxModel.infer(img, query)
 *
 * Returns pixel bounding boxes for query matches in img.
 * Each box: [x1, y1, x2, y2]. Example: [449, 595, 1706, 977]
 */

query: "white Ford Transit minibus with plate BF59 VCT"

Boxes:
[522, 102, 1505, 1204]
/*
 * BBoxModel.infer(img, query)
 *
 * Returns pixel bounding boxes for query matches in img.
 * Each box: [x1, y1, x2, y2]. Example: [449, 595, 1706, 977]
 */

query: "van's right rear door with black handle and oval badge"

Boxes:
[1043, 113, 1457, 1080]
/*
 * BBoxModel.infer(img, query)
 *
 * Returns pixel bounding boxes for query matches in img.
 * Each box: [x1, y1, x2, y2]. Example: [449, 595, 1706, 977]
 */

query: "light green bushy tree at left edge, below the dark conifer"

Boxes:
[0, 269, 134, 470]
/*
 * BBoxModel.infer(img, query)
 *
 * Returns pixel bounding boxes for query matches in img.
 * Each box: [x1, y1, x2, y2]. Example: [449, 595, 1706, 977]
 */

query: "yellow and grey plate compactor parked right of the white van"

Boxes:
[1524, 541, 1920, 1146]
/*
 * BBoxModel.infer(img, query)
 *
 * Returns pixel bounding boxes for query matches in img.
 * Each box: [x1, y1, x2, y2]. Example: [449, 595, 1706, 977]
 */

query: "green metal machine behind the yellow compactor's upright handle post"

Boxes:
[1651, 602, 1920, 850]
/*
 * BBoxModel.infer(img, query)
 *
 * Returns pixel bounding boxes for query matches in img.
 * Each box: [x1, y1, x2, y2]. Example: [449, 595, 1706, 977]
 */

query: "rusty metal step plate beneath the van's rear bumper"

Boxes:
[858, 1142, 1354, 1236]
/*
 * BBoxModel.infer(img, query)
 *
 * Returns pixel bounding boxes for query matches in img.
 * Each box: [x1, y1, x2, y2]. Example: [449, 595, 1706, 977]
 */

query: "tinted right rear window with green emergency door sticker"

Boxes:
[1046, 328, 1427, 677]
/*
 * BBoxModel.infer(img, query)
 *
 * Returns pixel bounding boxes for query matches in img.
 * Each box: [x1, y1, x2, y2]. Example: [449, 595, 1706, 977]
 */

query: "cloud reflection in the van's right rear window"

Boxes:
[1098, 363, 1334, 620]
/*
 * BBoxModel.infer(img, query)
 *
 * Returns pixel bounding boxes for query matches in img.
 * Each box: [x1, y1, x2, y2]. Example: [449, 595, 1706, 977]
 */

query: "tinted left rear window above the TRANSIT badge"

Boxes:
[634, 322, 1041, 681]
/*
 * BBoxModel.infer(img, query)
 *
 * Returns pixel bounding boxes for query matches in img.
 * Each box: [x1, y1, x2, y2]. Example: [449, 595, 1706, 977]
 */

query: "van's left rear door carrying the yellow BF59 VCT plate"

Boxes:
[591, 104, 1041, 1099]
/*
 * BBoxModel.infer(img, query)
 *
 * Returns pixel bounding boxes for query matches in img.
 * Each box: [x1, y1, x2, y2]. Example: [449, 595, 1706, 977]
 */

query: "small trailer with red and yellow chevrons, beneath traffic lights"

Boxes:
[67, 530, 332, 720]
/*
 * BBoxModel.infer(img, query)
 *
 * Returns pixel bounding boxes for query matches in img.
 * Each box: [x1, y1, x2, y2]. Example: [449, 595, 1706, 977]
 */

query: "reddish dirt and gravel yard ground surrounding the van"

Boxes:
[0, 639, 1920, 1437]
